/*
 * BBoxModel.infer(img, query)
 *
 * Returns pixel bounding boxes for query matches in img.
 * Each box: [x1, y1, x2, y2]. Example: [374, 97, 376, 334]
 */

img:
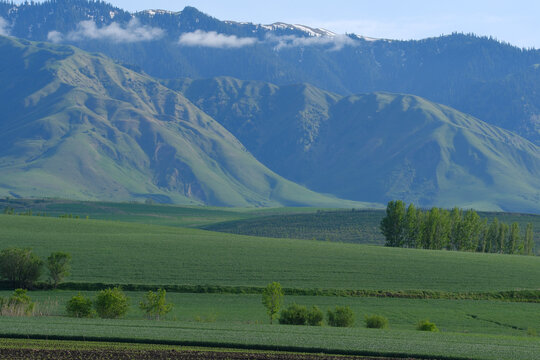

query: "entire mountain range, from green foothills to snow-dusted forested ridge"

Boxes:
[0, 0, 540, 212]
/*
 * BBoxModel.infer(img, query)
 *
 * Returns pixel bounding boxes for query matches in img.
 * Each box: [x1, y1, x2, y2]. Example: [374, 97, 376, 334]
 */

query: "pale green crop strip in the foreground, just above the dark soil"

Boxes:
[0, 318, 540, 360]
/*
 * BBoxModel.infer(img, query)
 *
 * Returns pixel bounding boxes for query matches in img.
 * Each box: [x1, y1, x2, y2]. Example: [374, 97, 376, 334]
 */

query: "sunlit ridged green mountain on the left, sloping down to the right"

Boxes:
[0, 37, 370, 207]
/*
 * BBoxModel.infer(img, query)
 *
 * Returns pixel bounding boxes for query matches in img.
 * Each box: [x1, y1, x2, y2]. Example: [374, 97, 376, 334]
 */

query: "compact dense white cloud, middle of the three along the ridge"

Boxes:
[178, 30, 257, 48]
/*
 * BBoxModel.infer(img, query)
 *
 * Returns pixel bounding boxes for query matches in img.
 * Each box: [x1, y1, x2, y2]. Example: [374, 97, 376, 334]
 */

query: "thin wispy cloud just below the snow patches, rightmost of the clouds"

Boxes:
[266, 35, 356, 51]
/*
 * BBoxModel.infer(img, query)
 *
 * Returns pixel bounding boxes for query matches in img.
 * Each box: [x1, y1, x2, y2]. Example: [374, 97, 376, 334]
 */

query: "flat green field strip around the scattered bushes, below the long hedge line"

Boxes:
[0, 291, 540, 336]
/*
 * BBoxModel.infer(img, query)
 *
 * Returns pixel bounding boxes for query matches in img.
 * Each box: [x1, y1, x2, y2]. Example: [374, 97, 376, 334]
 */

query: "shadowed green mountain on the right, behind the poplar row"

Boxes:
[173, 78, 540, 212]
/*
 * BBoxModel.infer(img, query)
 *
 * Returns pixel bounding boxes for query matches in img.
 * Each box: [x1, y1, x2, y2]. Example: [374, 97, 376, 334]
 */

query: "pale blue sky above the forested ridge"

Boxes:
[14, 0, 540, 48]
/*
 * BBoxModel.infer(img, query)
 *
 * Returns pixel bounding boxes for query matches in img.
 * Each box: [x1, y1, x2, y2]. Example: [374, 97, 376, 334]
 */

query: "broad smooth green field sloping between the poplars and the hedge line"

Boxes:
[0, 215, 540, 291]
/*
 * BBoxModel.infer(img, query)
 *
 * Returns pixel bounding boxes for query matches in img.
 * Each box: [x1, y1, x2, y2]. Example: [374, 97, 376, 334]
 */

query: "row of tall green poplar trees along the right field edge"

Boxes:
[380, 200, 534, 255]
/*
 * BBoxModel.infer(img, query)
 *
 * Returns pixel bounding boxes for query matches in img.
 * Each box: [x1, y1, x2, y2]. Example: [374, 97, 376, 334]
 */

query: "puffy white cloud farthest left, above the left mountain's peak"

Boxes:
[47, 19, 165, 43]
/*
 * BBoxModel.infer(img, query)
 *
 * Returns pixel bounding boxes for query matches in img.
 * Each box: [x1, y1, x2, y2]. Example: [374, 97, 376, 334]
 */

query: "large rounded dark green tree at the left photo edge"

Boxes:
[0, 248, 43, 288]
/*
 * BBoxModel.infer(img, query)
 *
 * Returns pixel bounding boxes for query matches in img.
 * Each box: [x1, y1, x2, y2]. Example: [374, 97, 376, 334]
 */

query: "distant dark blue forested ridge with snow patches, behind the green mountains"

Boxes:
[0, 0, 540, 145]
